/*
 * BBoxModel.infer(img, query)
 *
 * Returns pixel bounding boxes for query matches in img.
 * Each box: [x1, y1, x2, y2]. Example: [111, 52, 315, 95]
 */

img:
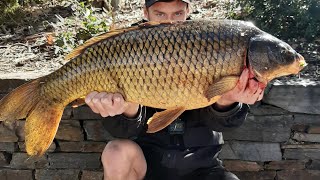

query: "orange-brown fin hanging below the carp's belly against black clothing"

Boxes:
[147, 107, 185, 133]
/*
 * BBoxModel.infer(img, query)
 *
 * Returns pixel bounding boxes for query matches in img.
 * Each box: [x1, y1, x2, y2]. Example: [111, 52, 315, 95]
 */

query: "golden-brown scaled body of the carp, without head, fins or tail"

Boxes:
[42, 21, 251, 109]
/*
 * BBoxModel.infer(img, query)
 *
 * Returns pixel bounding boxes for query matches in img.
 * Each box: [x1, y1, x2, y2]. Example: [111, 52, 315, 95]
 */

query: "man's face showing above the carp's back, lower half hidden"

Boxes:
[144, 0, 189, 21]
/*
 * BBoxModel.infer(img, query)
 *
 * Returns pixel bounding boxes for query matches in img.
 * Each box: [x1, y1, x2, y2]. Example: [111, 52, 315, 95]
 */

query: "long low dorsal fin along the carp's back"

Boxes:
[65, 21, 172, 61]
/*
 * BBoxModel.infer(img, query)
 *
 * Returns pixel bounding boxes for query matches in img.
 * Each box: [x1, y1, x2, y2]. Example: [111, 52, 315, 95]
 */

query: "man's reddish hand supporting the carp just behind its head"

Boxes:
[215, 68, 265, 109]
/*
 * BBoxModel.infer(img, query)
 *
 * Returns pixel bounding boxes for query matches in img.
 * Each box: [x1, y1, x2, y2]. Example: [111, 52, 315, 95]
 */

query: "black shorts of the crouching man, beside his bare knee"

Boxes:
[137, 142, 239, 180]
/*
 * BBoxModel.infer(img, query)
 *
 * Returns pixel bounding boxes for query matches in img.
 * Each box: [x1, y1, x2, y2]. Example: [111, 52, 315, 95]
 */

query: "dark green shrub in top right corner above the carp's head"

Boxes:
[227, 0, 320, 41]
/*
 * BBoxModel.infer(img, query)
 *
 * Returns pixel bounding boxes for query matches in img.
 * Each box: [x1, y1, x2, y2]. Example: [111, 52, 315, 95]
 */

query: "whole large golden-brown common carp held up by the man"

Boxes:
[0, 20, 306, 155]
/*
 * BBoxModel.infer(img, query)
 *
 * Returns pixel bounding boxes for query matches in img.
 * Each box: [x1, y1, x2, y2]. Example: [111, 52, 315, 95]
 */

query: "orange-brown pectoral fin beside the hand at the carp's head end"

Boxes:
[205, 76, 239, 101]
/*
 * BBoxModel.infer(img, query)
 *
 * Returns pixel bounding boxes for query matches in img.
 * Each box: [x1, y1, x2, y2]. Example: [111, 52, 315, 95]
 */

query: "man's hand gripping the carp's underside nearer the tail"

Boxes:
[85, 91, 139, 118]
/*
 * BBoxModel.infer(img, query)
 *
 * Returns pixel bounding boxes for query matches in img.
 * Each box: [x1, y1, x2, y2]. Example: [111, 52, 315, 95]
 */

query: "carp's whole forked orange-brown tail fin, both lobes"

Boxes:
[0, 79, 64, 155]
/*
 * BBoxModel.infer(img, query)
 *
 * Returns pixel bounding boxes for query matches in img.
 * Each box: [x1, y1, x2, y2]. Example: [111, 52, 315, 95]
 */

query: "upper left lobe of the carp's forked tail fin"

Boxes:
[0, 79, 40, 122]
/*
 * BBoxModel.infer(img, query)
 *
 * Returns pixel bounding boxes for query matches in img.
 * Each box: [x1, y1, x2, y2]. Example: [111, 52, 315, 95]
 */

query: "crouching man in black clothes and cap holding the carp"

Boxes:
[86, 0, 263, 180]
